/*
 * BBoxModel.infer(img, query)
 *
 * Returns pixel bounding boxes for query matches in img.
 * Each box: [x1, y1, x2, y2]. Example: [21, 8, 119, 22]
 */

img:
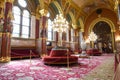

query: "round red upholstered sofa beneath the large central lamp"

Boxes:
[42, 47, 78, 64]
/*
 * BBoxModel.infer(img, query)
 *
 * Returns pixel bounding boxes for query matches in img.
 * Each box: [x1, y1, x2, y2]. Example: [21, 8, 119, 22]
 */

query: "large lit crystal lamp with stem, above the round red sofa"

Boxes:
[52, 13, 68, 46]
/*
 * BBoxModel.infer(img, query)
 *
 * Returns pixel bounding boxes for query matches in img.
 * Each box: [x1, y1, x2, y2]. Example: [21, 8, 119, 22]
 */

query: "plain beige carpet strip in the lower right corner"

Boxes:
[81, 53, 114, 80]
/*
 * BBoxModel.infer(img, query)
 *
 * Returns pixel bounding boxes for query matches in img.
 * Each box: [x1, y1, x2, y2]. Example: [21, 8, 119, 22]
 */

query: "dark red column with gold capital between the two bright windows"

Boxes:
[40, 9, 48, 57]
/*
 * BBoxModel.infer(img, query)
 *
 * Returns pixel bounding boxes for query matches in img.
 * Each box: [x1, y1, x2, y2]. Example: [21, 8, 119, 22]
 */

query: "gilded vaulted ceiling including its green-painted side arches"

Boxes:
[30, 0, 119, 29]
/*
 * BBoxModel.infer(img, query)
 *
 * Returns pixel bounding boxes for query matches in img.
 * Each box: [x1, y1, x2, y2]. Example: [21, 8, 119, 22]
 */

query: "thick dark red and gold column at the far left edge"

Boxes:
[0, 0, 14, 62]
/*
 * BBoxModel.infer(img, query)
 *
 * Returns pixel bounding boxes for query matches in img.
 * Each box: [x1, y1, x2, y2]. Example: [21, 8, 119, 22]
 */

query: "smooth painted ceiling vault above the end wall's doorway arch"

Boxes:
[72, 0, 115, 14]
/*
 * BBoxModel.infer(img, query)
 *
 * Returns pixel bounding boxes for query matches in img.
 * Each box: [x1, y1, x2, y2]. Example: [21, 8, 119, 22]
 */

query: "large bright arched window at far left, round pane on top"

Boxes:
[12, 0, 30, 38]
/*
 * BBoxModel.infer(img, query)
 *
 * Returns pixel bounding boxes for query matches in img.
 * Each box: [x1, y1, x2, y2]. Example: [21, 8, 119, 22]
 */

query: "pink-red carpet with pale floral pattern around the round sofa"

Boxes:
[0, 55, 113, 80]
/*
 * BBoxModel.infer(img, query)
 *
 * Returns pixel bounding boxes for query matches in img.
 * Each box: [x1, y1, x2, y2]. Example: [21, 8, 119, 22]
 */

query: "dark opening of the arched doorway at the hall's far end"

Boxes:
[93, 21, 113, 53]
